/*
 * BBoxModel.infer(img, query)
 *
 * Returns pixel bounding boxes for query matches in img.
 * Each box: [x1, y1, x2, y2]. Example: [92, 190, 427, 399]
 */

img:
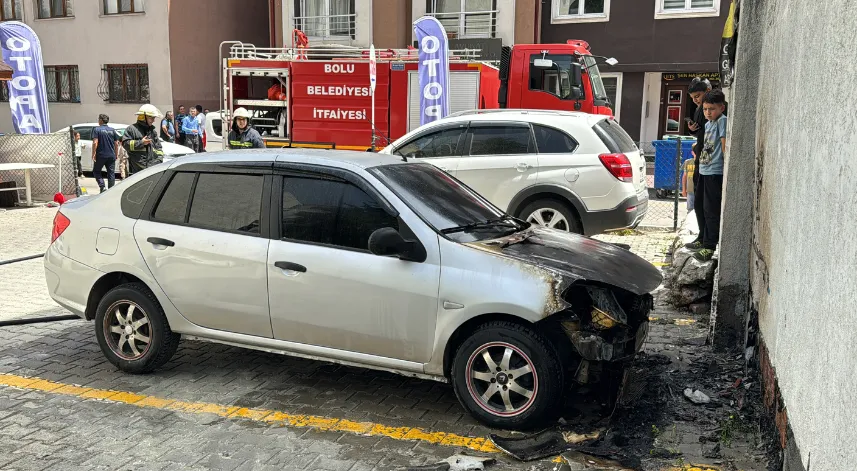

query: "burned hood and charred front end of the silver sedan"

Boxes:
[470, 226, 662, 384]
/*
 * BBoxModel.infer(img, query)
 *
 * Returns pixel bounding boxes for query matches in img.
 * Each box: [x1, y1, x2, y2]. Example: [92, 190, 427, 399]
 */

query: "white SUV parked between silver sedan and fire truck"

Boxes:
[381, 110, 649, 235]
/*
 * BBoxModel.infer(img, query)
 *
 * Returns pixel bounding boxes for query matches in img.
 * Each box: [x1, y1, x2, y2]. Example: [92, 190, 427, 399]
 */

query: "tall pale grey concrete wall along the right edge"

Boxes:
[722, 0, 857, 471]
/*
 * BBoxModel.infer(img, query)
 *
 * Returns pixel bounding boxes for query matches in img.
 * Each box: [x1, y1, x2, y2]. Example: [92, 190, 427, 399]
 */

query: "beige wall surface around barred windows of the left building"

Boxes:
[0, 0, 175, 133]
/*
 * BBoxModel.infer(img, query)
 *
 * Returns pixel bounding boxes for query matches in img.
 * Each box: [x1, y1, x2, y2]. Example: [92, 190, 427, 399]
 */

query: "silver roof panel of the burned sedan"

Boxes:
[170, 148, 405, 169]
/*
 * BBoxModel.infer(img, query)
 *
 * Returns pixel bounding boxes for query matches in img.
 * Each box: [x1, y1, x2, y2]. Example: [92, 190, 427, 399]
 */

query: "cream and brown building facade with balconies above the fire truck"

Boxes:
[271, 0, 538, 60]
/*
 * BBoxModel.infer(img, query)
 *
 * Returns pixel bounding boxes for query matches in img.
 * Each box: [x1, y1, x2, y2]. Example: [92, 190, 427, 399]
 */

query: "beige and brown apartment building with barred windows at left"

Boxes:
[0, 0, 270, 133]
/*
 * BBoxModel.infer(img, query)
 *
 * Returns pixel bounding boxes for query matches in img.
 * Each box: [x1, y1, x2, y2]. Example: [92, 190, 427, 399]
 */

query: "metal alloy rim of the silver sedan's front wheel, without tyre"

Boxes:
[466, 342, 539, 417]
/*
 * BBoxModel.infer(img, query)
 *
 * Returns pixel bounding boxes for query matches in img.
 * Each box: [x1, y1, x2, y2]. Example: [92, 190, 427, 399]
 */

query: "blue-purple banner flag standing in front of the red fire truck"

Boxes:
[414, 16, 449, 125]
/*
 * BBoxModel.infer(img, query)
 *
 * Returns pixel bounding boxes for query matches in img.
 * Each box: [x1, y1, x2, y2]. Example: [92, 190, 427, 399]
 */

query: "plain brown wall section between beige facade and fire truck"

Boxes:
[169, 0, 270, 110]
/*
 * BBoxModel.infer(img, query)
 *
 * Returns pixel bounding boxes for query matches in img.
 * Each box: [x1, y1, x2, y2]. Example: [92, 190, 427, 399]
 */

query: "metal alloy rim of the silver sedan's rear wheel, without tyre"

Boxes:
[103, 301, 152, 360]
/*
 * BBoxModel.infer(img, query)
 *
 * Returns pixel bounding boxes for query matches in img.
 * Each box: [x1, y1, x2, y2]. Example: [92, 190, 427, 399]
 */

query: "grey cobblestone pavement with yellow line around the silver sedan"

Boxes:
[0, 208, 749, 471]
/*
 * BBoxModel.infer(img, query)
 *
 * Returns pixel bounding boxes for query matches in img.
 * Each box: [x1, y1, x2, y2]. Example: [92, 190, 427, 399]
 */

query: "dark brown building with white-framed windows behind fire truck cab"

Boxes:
[538, 0, 731, 141]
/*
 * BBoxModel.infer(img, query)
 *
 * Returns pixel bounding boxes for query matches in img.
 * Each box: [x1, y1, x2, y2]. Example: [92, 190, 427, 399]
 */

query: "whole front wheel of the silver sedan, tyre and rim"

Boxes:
[451, 321, 565, 429]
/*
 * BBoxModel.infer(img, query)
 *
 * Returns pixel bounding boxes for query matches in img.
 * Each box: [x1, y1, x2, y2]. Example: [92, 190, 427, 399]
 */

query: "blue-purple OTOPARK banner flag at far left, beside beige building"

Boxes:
[0, 21, 51, 134]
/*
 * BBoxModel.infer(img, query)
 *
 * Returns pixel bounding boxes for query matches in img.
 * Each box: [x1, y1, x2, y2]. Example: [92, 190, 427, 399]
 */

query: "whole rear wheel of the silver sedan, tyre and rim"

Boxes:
[95, 283, 181, 374]
